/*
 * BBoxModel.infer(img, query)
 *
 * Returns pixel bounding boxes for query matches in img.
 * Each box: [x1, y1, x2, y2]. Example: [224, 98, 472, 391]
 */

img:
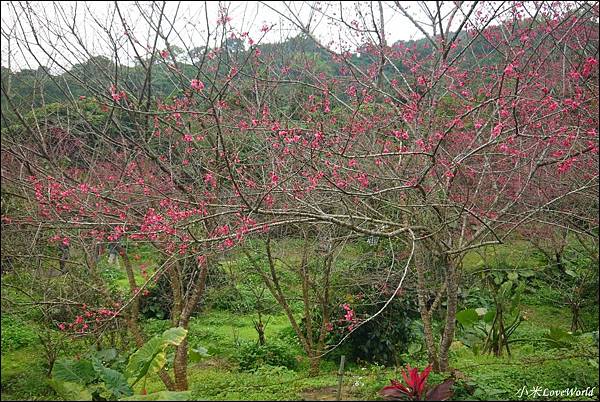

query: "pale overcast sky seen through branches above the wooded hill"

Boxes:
[1, 1, 466, 70]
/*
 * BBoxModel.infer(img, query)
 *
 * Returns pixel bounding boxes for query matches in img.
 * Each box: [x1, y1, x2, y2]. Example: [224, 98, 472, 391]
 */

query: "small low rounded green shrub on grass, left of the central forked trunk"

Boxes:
[236, 342, 297, 370]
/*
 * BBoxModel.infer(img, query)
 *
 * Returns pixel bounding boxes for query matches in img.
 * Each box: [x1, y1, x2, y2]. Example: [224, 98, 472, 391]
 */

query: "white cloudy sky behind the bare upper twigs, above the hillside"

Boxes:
[1, 1, 474, 71]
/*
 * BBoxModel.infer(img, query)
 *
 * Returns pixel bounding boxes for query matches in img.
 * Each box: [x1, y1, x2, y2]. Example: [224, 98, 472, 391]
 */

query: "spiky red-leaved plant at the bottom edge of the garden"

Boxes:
[380, 365, 454, 401]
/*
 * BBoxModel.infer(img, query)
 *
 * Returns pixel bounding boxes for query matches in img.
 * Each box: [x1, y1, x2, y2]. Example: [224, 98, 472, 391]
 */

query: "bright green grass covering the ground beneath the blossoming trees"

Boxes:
[2, 239, 598, 400]
